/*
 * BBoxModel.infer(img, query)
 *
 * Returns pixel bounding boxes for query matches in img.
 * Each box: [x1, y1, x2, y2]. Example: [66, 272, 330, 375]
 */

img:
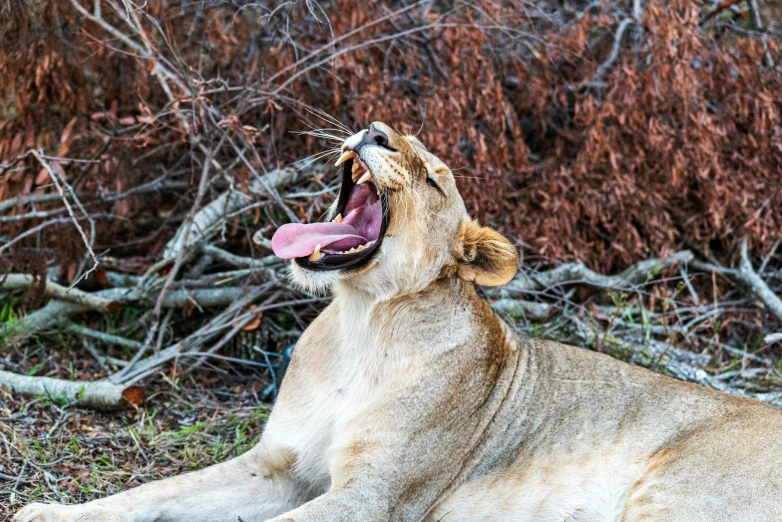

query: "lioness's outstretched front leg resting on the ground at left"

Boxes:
[14, 441, 305, 522]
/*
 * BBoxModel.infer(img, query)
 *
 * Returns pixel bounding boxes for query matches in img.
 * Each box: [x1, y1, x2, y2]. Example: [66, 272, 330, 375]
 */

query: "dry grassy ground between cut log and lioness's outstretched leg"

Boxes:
[0, 356, 270, 520]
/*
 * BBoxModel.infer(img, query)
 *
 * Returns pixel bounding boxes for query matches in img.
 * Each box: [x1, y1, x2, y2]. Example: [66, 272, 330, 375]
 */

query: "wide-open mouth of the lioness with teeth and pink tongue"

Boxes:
[272, 151, 388, 270]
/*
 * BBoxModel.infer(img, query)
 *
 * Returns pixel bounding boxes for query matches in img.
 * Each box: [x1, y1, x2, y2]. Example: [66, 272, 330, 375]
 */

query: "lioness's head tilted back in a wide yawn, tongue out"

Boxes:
[272, 122, 518, 298]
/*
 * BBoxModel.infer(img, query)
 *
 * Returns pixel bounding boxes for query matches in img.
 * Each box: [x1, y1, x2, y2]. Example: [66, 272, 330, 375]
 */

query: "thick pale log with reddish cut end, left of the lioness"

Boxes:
[0, 370, 144, 411]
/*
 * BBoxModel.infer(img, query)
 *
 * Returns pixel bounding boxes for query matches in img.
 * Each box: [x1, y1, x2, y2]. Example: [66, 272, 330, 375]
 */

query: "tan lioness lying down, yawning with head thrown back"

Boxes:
[15, 123, 782, 522]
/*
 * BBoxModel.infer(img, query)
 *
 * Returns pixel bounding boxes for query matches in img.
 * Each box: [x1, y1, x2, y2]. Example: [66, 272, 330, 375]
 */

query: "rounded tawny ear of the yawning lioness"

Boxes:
[458, 220, 519, 286]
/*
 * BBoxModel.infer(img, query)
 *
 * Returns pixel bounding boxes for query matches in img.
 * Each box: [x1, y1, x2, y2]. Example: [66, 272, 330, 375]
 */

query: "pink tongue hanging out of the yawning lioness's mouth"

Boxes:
[272, 223, 367, 259]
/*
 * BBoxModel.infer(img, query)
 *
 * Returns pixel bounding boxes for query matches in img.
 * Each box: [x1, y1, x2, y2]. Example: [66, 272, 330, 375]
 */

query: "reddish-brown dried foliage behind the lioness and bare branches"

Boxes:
[0, 0, 782, 270]
